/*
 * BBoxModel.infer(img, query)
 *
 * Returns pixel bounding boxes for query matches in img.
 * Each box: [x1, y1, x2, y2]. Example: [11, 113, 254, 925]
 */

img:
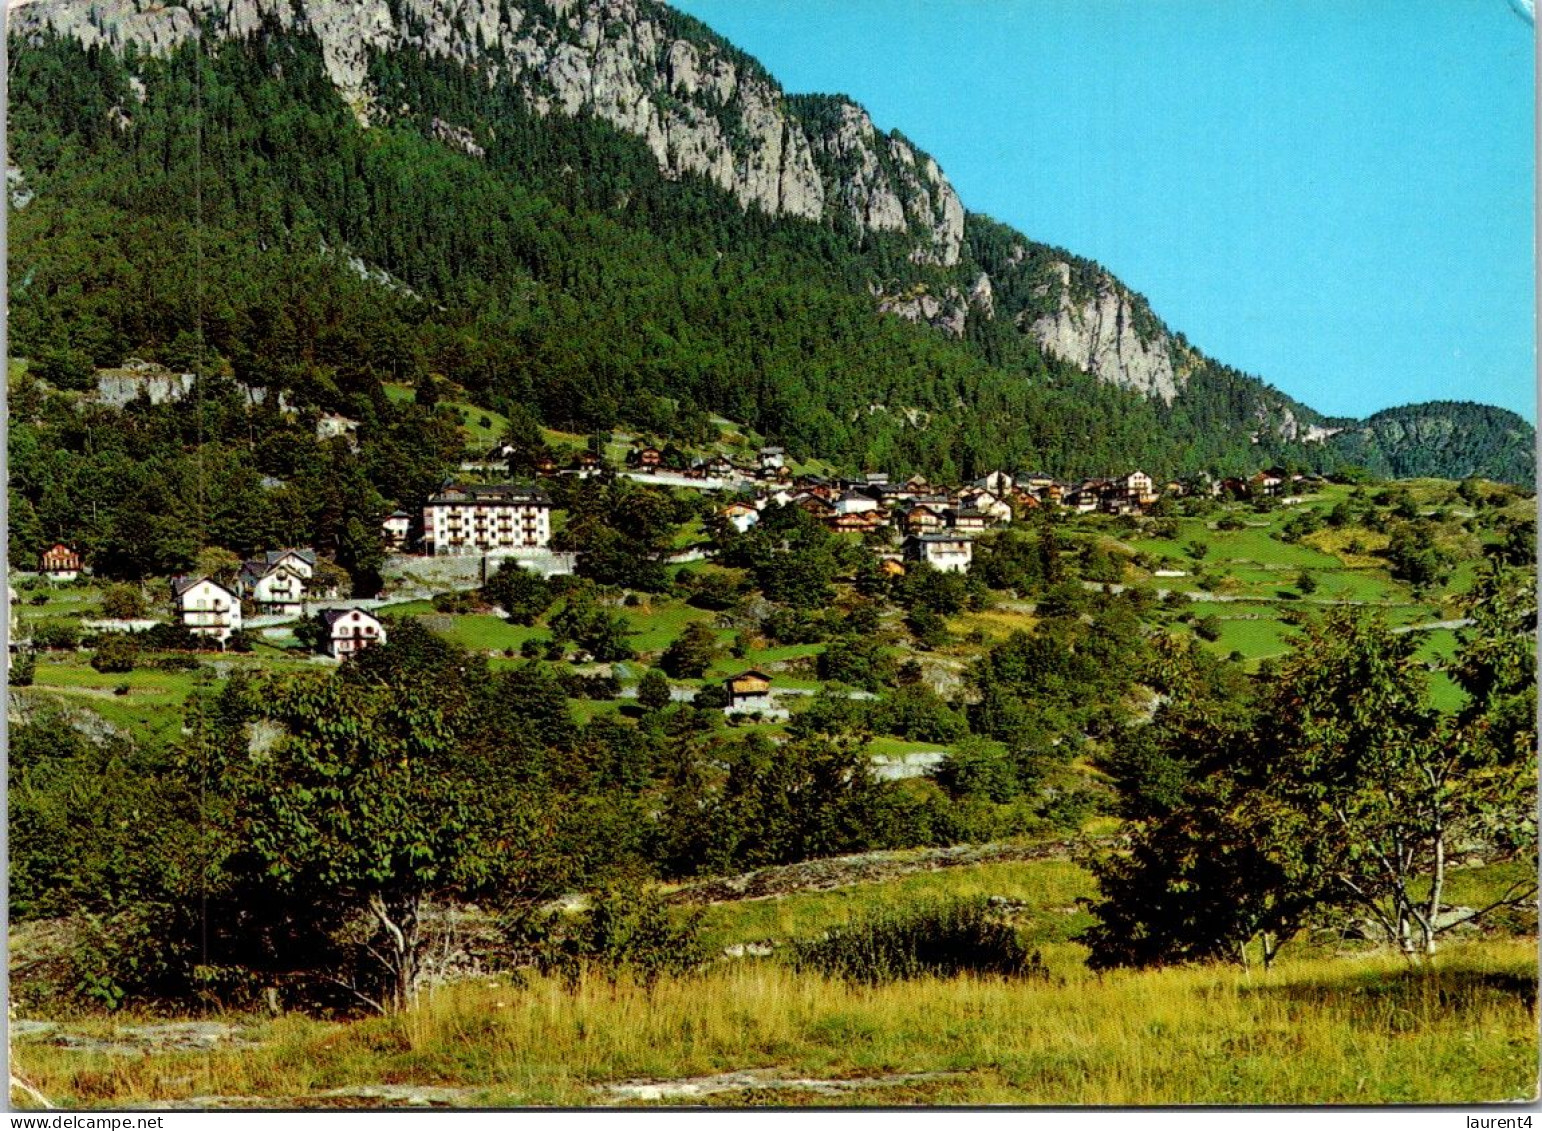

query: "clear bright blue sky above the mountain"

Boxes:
[675, 0, 1536, 421]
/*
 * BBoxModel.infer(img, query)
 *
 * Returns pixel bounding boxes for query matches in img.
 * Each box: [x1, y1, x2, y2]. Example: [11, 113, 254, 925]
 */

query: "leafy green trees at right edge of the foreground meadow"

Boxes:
[1086, 566, 1536, 967]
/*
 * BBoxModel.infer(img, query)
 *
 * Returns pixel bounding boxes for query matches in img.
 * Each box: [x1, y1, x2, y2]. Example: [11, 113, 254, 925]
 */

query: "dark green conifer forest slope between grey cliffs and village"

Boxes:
[11, 31, 1350, 477]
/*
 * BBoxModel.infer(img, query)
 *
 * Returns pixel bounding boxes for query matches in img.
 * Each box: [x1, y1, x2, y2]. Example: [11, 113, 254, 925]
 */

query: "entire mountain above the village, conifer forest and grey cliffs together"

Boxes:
[8, 0, 1533, 484]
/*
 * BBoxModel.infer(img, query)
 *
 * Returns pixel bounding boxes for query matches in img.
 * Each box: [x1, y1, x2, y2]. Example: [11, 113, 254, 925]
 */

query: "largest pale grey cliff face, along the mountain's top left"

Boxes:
[9, 0, 964, 267]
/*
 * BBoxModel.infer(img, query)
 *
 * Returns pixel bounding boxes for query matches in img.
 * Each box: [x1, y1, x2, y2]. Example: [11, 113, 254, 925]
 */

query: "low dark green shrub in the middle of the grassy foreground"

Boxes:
[791, 898, 1047, 986]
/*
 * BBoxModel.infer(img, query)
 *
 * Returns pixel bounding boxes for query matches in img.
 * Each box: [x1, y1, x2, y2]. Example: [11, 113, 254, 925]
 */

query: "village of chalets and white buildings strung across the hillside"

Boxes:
[9, 414, 1325, 660]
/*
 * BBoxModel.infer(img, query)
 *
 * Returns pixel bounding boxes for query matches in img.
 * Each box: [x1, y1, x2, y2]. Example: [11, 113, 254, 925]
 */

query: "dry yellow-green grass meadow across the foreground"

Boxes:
[12, 941, 1537, 1108]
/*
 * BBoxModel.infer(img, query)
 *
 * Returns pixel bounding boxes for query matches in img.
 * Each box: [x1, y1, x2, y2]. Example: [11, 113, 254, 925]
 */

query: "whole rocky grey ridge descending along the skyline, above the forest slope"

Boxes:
[11, 0, 1529, 481]
